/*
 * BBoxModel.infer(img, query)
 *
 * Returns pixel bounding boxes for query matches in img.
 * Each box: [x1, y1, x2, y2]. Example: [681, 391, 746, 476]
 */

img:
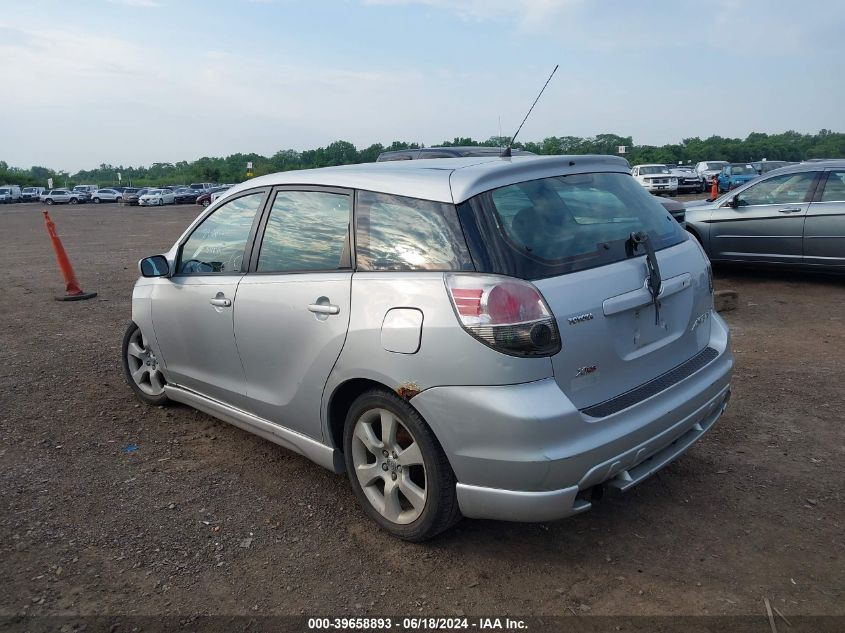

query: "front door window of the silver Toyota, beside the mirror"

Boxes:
[176, 192, 264, 275]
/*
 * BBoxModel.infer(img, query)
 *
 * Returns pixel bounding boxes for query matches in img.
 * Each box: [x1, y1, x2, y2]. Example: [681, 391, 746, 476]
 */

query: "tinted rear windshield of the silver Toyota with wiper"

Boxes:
[459, 173, 686, 279]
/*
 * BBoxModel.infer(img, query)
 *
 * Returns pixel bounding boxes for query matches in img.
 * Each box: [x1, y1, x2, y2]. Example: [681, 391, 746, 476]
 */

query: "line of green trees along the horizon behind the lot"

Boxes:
[0, 130, 845, 187]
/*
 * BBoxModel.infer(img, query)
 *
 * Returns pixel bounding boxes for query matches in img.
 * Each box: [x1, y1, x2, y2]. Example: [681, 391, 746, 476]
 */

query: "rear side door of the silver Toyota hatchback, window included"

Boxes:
[235, 187, 352, 440]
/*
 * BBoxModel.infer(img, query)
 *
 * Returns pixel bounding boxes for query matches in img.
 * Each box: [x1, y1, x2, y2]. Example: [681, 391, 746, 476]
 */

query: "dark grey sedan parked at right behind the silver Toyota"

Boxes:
[686, 160, 845, 272]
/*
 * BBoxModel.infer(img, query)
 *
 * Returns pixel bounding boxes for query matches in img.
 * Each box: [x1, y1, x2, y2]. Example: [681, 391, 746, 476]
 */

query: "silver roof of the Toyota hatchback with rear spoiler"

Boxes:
[226, 155, 630, 204]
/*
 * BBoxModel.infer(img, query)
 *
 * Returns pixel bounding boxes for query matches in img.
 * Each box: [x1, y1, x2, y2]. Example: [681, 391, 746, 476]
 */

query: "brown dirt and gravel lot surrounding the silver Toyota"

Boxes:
[0, 200, 845, 630]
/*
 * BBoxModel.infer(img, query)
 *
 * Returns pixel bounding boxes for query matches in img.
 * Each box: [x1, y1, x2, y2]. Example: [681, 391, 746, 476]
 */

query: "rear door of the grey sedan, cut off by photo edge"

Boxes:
[804, 169, 845, 267]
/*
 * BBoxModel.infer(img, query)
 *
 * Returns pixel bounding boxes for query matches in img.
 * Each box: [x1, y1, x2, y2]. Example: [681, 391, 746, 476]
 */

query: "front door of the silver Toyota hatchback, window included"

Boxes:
[151, 191, 266, 407]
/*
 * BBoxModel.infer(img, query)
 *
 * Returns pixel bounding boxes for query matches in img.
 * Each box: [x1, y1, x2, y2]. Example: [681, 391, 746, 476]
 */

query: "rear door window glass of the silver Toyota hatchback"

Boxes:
[257, 191, 352, 273]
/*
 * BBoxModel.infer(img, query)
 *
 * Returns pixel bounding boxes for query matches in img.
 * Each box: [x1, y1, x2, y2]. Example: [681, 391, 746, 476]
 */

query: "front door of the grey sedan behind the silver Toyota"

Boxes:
[710, 171, 818, 264]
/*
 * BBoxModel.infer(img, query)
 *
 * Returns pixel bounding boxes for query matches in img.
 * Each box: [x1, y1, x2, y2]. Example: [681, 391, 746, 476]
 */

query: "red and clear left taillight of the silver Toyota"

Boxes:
[446, 274, 560, 356]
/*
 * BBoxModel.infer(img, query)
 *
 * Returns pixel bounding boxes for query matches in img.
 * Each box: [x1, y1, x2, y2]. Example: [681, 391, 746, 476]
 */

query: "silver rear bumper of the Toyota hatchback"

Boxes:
[412, 313, 733, 521]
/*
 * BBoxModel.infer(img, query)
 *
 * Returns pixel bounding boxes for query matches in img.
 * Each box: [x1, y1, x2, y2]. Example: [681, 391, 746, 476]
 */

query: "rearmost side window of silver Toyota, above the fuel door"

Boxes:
[355, 191, 473, 270]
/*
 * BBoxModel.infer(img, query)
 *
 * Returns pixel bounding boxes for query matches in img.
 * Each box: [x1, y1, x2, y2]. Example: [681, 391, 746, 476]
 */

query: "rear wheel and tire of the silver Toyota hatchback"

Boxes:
[343, 389, 461, 542]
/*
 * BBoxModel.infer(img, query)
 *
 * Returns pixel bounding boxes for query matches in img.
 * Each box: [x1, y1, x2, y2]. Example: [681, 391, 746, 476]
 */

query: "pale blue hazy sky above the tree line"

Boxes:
[0, 0, 845, 173]
